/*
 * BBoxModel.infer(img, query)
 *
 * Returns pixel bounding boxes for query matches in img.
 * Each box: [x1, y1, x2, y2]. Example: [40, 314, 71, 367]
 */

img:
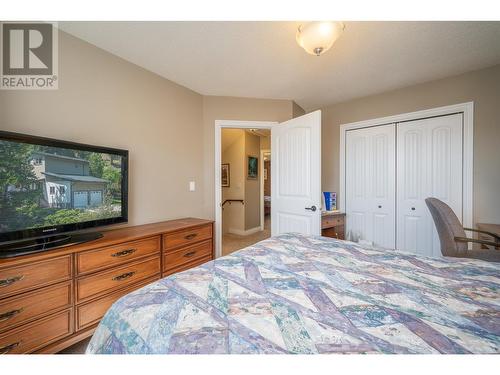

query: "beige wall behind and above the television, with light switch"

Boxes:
[0, 32, 204, 224]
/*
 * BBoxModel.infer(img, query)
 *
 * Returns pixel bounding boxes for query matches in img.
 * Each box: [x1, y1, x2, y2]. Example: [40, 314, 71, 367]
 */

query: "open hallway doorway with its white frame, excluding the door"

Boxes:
[215, 120, 276, 257]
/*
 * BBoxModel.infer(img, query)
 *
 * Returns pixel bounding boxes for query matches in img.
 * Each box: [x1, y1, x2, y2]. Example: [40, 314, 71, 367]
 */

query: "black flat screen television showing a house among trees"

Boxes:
[0, 131, 128, 257]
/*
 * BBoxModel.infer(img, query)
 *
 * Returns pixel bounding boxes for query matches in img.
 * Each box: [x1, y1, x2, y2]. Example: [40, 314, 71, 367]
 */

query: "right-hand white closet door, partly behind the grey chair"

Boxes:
[397, 114, 463, 256]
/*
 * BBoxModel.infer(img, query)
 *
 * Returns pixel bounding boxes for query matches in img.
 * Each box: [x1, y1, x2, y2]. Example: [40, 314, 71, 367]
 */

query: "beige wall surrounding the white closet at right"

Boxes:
[321, 65, 500, 223]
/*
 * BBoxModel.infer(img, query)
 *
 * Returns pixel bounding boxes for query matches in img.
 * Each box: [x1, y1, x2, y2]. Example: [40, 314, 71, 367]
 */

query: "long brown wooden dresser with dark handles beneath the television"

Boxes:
[0, 218, 214, 354]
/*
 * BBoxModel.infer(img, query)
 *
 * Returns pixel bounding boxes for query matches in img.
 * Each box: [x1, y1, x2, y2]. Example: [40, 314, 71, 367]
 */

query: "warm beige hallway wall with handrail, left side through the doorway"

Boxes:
[221, 129, 246, 233]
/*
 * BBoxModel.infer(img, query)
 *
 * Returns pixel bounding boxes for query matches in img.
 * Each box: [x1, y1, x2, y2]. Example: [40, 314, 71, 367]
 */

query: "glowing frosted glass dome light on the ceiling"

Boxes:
[295, 22, 345, 56]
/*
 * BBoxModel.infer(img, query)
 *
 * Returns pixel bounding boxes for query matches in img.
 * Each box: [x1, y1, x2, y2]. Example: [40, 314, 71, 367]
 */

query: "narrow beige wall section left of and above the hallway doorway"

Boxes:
[200, 96, 293, 219]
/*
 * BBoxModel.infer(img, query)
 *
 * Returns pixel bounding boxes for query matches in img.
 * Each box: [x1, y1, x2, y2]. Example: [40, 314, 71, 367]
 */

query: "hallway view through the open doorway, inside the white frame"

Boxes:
[220, 128, 271, 255]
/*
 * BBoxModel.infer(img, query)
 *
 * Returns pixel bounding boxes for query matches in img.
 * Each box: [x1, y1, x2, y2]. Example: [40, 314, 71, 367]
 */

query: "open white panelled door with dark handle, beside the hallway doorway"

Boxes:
[271, 111, 321, 236]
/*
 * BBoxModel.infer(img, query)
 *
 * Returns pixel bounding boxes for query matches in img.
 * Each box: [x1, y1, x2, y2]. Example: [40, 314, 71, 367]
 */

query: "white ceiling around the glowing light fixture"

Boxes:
[59, 22, 500, 110]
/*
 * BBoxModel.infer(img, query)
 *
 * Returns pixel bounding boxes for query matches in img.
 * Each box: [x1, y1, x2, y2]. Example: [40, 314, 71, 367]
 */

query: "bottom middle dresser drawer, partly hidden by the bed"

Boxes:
[76, 275, 160, 330]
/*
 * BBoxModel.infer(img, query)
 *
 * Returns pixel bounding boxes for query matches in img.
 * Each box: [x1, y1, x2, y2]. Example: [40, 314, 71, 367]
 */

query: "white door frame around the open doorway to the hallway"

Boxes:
[214, 120, 278, 258]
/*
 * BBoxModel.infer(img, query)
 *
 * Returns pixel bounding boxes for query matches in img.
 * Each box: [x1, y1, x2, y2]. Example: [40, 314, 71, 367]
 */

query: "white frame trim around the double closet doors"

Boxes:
[338, 102, 474, 234]
